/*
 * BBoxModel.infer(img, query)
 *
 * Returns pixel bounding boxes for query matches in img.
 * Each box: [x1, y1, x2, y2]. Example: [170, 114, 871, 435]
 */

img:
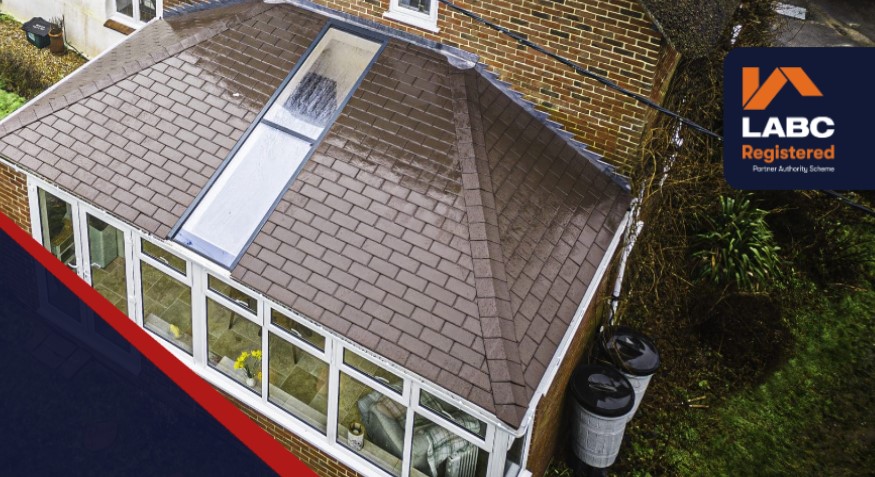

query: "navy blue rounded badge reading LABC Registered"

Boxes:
[723, 48, 875, 190]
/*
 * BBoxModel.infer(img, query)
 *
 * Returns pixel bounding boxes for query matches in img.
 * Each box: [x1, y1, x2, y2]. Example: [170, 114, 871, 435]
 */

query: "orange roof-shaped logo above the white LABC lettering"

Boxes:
[741, 66, 823, 111]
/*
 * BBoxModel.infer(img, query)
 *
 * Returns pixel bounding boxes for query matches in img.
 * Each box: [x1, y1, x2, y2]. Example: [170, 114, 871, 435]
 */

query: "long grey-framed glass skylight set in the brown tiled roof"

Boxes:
[173, 26, 384, 268]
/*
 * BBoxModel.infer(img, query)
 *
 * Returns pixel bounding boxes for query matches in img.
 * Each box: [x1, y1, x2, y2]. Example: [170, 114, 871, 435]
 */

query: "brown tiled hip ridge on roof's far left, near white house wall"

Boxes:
[0, 0, 274, 136]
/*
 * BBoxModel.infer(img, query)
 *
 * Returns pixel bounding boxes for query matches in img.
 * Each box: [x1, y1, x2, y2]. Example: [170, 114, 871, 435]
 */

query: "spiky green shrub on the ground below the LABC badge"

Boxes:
[692, 196, 780, 291]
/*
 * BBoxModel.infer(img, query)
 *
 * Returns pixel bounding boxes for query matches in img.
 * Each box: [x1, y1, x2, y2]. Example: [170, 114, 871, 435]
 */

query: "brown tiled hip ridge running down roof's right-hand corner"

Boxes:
[451, 68, 526, 422]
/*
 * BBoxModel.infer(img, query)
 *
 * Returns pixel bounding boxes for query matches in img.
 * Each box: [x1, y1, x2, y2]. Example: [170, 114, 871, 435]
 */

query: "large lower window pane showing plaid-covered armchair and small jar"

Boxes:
[337, 373, 407, 475]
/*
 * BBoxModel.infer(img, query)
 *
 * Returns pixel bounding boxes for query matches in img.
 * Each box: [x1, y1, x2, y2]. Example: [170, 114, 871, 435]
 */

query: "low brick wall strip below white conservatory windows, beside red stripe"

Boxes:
[218, 390, 363, 477]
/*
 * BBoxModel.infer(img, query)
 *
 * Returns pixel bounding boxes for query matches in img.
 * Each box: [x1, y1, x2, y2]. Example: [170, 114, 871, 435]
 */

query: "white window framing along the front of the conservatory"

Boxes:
[28, 174, 531, 477]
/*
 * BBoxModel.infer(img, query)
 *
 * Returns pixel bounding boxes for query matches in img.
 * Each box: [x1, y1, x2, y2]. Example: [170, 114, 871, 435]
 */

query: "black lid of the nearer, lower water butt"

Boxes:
[570, 364, 635, 417]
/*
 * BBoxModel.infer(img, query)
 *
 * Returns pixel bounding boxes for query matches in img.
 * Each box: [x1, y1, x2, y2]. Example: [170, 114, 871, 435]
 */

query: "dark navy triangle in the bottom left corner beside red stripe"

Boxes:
[0, 230, 280, 477]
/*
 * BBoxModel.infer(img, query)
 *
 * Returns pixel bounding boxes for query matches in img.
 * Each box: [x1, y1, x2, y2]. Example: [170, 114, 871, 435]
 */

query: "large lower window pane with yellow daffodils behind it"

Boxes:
[207, 298, 261, 394]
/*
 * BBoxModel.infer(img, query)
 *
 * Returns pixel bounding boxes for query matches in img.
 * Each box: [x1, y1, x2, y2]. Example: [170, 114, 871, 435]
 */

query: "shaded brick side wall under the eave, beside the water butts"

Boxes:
[526, 262, 619, 476]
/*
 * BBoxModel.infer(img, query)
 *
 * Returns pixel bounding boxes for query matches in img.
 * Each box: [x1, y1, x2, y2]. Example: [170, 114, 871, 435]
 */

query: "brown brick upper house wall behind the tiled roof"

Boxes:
[314, 0, 674, 167]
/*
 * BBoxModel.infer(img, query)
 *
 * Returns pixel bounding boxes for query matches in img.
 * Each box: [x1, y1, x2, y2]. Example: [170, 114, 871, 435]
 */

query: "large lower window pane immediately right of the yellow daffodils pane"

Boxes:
[267, 333, 328, 434]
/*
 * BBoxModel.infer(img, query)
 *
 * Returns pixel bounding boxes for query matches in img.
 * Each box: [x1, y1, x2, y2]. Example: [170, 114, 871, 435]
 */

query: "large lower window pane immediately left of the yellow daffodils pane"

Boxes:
[140, 261, 191, 354]
